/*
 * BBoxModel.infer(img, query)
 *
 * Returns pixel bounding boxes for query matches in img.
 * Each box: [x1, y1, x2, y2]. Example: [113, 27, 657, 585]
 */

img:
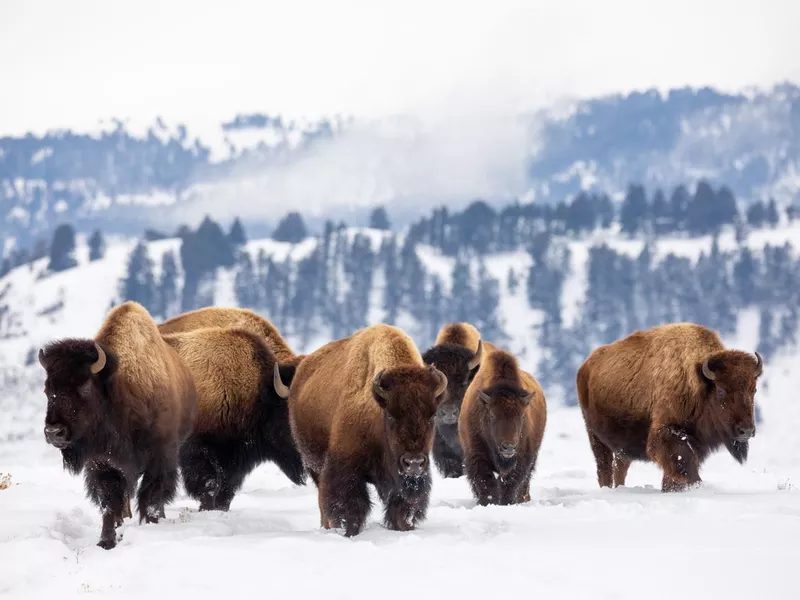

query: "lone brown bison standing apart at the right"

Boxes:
[577, 323, 762, 491]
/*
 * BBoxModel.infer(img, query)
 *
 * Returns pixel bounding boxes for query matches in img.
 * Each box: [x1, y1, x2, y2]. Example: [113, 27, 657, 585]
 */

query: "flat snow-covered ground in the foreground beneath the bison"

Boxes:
[0, 350, 800, 600]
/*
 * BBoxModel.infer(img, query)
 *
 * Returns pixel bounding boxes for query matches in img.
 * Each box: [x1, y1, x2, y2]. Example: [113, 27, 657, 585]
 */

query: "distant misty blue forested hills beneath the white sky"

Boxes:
[0, 85, 800, 243]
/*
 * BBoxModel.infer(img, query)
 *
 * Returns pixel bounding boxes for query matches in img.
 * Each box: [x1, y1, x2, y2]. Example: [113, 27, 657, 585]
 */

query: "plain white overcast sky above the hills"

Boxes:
[0, 0, 800, 133]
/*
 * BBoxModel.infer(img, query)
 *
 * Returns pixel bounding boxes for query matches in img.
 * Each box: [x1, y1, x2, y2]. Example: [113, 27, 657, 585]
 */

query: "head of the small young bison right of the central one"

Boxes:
[478, 382, 534, 473]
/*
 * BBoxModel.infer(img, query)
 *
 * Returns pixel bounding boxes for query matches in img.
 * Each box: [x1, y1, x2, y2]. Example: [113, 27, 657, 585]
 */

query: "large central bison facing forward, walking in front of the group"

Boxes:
[276, 325, 447, 537]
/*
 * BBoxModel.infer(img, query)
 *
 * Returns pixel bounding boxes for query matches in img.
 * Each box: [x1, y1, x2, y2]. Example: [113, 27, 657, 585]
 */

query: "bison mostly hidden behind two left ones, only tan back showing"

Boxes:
[158, 306, 303, 365]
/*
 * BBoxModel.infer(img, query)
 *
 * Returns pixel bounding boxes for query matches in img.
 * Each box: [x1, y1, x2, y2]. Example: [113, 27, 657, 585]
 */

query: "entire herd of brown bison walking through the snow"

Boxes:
[39, 302, 762, 549]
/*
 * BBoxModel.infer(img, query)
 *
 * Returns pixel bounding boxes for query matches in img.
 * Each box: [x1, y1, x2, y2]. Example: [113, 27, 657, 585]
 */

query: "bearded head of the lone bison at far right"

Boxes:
[700, 350, 763, 462]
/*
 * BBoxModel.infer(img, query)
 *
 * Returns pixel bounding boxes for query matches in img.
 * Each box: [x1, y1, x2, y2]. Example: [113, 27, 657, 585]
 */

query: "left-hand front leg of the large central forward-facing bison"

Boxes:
[319, 456, 372, 537]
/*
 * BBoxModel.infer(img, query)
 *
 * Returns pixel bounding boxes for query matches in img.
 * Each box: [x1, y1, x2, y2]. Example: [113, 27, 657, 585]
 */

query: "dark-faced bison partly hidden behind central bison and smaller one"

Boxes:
[422, 323, 483, 477]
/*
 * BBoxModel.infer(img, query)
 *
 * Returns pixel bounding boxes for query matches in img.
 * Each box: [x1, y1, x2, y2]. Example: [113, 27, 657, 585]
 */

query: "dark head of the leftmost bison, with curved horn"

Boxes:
[39, 339, 116, 470]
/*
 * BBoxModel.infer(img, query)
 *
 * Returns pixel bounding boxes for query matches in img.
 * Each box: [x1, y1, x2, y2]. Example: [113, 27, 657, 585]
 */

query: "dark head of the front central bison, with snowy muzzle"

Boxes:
[372, 365, 447, 494]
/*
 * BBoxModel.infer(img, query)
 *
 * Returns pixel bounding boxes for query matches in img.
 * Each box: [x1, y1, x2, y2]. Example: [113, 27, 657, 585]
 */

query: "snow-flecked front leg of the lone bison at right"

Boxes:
[647, 422, 701, 492]
